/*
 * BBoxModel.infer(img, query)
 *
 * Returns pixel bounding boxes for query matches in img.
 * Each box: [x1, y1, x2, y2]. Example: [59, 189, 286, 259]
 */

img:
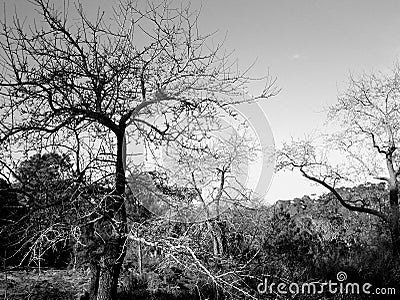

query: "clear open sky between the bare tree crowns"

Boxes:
[0, 0, 400, 202]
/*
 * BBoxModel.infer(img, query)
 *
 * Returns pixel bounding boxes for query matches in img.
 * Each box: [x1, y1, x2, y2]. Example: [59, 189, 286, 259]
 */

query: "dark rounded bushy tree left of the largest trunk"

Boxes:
[2, 153, 76, 267]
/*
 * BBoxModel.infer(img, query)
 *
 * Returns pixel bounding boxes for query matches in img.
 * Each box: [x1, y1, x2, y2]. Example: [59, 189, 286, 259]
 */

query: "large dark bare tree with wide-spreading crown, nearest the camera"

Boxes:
[0, 0, 277, 299]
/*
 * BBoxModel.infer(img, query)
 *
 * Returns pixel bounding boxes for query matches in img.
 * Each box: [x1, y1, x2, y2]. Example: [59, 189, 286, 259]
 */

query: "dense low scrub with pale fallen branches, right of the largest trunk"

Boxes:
[3, 184, 400, 299]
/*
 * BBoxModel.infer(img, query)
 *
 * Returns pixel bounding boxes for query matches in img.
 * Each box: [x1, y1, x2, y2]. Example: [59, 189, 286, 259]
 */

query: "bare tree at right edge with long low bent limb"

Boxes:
[278, 65, 400, 256]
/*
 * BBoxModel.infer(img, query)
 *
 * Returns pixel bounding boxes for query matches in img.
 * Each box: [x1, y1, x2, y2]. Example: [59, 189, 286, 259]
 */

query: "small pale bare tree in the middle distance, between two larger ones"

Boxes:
[170, 124, 262, 257]
